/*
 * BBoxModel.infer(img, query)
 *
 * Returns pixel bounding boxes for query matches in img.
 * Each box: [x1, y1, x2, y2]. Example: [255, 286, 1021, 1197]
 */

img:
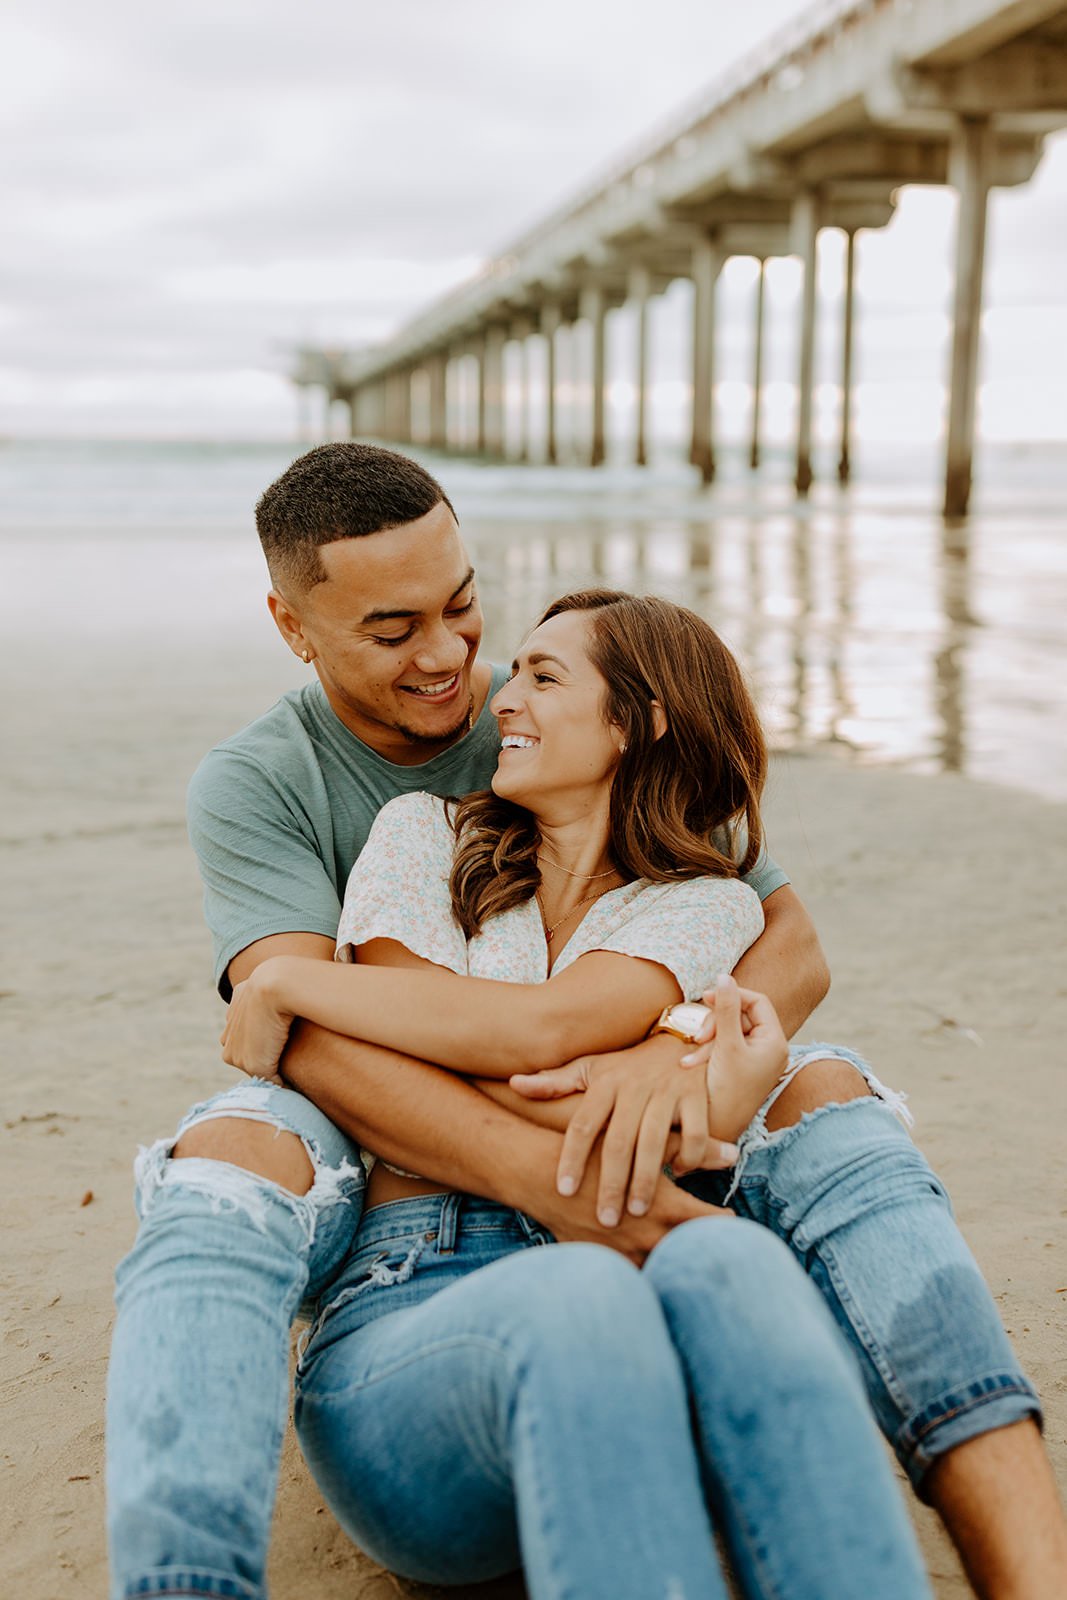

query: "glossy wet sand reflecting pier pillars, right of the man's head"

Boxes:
[466, 473, 1067, 795]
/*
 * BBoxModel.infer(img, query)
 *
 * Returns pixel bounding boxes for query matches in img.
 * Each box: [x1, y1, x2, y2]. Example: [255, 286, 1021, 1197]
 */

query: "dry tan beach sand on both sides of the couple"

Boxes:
[0, 624, 1067, 1600]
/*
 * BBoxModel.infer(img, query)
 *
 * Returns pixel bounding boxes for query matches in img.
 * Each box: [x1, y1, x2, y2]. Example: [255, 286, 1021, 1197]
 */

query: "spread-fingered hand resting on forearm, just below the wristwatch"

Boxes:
[510, 1035, 737, 1232]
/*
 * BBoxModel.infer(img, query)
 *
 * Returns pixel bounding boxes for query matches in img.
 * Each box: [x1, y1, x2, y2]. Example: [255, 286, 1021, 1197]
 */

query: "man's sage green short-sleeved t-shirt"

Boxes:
[189, 667, 789, 1000]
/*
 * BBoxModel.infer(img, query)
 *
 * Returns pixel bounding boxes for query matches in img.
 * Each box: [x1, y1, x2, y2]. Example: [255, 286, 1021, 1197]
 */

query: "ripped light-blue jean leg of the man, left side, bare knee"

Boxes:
[107, 1080, 365, 1600]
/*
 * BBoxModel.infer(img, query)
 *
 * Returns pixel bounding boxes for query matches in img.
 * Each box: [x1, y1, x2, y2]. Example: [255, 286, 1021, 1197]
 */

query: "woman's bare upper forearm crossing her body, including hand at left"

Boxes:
[222, 939, 681, 1078]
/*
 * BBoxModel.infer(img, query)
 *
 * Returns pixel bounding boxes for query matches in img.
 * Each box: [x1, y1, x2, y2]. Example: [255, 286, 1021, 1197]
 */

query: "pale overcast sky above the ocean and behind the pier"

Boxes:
[0, 0, 1067, 437]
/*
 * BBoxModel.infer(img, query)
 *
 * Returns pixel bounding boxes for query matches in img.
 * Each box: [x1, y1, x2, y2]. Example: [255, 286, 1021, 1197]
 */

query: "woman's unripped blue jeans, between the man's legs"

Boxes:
[296, 1194, 929, 1600]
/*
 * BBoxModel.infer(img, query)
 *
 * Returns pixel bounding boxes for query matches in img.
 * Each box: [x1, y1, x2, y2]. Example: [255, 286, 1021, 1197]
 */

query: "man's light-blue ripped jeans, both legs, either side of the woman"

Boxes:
[107, 1046, 1038, 1600]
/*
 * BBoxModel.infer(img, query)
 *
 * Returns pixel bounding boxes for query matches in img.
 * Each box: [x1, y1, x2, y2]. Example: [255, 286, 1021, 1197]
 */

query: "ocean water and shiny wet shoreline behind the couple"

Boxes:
[0, 442, 1067, 800]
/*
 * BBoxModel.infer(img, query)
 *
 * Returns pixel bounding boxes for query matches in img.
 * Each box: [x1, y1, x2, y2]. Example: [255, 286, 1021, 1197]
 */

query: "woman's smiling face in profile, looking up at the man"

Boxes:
[490, 611, 622, 816]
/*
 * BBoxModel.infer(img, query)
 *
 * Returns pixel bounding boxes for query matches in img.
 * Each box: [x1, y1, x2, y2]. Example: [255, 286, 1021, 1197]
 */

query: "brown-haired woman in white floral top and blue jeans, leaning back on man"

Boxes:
[224, 590, 928, 1600]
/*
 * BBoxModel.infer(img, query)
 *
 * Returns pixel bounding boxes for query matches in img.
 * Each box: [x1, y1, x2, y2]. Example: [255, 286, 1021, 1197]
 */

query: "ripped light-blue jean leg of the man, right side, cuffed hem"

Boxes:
[681, 1043, 1041, 1499]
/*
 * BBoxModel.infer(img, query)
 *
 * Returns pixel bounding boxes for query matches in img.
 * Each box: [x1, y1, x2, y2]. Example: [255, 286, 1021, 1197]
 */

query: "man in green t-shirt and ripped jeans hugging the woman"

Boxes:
[109, 445, 1067, 1600]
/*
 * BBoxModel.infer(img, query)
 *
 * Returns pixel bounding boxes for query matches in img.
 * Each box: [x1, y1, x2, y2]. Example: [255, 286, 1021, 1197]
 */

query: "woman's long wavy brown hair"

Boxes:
[450, 589, 766, 939]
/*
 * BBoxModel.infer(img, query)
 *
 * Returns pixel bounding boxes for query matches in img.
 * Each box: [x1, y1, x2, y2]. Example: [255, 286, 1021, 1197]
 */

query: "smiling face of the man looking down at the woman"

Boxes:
[272, 501, 482, 765]
